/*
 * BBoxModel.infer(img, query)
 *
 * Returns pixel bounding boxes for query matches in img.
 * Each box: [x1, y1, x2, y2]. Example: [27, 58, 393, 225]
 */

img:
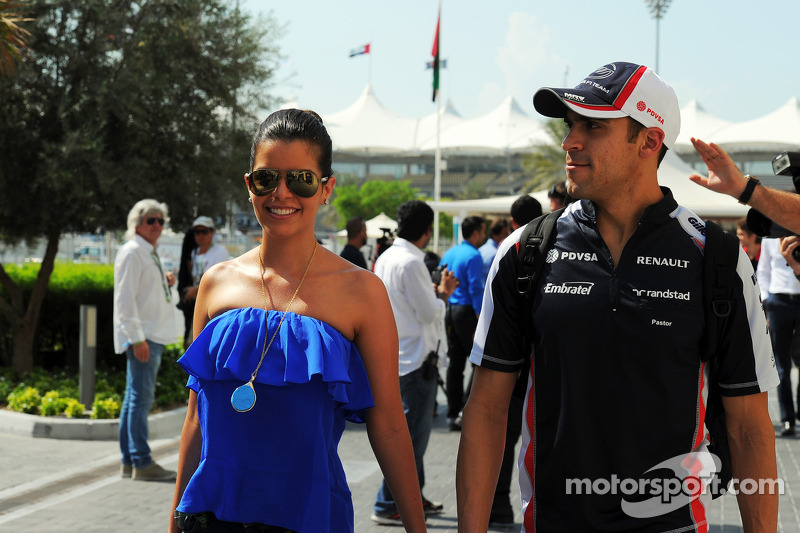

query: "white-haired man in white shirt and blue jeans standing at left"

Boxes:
[114, 199, 177, 481]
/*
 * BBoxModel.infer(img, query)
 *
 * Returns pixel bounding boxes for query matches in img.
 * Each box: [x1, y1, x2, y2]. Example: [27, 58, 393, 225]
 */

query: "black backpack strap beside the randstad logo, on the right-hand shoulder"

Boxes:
[700, 220, 740, 361]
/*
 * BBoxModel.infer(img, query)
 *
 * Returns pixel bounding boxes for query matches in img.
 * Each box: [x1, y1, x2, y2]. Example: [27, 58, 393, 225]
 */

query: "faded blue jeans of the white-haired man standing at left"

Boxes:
[119, 341, 164, 468]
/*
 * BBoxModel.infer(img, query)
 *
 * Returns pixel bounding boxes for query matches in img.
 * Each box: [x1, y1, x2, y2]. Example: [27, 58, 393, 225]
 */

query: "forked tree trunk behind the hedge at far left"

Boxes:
[0, 232, 61, 373]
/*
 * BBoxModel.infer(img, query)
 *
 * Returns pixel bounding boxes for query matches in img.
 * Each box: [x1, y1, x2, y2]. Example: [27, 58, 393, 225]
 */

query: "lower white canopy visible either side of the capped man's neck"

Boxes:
[429, 151, 748, 218]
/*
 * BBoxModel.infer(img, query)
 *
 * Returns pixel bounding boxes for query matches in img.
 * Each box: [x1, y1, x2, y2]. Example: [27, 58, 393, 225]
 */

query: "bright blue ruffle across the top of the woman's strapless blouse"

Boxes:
[178, 307, 375, 423]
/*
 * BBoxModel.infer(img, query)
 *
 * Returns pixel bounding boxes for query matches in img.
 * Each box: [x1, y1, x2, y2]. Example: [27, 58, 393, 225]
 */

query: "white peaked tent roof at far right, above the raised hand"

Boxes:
[711, 96, 800, 152]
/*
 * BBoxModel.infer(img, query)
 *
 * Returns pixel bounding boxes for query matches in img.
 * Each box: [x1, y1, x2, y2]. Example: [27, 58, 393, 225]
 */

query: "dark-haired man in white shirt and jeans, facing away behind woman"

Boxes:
[372, 200, 458, 525]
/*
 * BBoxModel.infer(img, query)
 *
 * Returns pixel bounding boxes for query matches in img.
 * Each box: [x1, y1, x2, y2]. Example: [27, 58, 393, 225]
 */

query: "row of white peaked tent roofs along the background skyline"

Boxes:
[292, 85, 800, 157]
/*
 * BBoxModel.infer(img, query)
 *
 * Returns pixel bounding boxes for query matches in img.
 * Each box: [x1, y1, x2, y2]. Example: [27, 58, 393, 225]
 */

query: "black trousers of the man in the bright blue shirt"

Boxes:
[445, 304, 478, 418]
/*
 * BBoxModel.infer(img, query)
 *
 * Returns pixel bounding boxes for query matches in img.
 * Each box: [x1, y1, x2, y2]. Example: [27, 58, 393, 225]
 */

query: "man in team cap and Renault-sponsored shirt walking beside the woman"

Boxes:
[456, 62, 778, 531]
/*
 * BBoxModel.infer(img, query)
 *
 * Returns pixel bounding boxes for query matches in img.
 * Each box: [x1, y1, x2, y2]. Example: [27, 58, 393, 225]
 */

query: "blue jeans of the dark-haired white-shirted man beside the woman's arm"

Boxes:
[374, 367, 438, 515]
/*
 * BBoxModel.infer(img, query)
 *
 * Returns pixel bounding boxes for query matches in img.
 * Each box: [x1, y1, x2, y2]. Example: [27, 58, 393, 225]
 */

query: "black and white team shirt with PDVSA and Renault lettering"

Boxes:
[470, 188, 779, 532]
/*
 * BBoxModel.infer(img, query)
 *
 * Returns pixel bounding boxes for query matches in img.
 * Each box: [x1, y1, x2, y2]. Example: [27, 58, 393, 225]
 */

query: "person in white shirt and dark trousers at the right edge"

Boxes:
[756, 239, 800, 437]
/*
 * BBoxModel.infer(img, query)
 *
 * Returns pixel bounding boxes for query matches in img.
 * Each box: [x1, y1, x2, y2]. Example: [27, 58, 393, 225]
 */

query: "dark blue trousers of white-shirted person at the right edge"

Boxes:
[764, 294, 800, 426]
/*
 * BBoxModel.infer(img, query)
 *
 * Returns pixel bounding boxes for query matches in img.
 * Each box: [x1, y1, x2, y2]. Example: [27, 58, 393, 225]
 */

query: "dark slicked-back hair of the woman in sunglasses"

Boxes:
[250, 109, 333, 178]
